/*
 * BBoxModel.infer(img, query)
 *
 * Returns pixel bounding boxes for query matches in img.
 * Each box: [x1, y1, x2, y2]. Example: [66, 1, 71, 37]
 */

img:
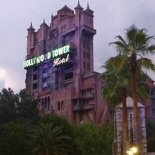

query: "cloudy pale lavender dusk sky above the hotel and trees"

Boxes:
[0, 0, 155, 92]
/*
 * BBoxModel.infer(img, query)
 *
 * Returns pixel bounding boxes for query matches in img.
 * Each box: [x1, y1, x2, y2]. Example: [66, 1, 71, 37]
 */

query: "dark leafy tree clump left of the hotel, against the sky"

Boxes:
[0, 88, 39, 123]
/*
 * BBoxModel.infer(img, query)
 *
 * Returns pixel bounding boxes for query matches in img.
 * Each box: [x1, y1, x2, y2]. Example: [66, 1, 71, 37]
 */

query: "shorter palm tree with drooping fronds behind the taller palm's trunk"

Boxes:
[100, 55, 149, 151]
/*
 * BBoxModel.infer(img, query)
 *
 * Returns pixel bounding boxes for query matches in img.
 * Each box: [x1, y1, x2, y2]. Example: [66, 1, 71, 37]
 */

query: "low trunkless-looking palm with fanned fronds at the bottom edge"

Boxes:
[30, 123, 69, 155]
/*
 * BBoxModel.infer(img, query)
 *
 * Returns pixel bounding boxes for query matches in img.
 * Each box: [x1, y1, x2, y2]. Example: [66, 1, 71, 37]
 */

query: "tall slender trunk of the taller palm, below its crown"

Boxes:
[131, 55, 139, 145]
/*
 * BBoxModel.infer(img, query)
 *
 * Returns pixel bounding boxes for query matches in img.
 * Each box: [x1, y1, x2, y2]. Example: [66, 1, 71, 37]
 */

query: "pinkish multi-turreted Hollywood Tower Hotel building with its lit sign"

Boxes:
[23, 3, 108, 124]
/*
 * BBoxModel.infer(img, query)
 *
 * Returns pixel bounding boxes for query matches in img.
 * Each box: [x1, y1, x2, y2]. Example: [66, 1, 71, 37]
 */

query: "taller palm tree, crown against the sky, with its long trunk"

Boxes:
[110, 25, 155, 150]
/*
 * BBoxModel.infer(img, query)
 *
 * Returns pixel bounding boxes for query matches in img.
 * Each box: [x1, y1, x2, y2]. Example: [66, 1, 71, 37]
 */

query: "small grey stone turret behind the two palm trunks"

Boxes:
[113, 97, 147, 155]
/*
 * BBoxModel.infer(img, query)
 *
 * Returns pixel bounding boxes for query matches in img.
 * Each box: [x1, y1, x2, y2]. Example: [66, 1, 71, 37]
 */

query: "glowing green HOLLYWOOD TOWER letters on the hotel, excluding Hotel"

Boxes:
[23, 45, 70, 68]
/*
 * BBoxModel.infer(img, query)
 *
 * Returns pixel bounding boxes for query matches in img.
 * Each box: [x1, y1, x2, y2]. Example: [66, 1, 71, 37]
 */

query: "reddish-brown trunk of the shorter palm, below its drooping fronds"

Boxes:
[122, 88, 129, 154]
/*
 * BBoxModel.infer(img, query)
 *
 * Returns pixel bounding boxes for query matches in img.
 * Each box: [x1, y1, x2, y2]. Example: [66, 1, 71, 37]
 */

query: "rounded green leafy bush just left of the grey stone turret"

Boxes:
[75, 122, 113, 155]
